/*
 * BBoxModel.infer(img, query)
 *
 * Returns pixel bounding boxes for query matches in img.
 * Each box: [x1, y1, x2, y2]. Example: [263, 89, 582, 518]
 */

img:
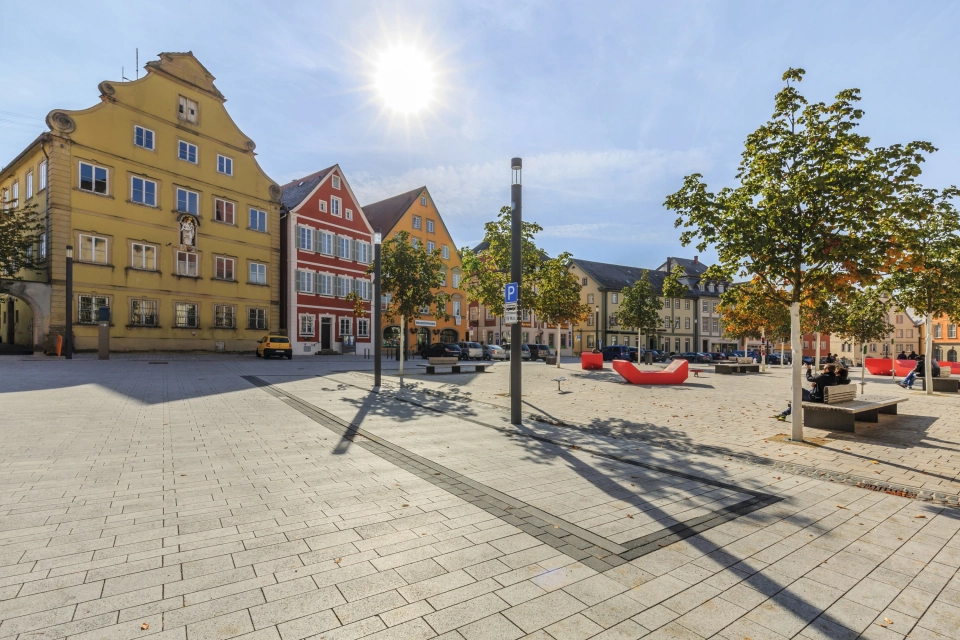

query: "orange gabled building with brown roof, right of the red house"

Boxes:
[363, 187, 469, 350]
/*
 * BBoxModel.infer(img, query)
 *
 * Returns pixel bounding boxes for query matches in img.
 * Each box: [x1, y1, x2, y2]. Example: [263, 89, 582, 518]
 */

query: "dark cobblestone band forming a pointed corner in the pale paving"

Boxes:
[242, 375, 781, 572]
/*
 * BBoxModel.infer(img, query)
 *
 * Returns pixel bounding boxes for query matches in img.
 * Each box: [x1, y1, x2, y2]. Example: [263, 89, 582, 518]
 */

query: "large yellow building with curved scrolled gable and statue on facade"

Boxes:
[0, 52, 280, 351]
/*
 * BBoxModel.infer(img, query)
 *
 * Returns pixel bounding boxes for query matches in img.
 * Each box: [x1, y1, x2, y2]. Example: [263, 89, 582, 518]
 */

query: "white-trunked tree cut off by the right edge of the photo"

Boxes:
[886, 186, 960, 394]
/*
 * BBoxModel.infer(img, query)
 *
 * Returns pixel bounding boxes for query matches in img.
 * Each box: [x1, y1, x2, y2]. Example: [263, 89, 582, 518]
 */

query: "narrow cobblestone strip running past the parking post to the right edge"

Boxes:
[360, 371, 960, 507]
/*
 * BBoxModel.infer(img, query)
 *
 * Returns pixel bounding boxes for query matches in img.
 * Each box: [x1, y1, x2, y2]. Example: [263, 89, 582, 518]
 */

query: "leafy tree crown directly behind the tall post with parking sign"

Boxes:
[460, 207, 544, 316]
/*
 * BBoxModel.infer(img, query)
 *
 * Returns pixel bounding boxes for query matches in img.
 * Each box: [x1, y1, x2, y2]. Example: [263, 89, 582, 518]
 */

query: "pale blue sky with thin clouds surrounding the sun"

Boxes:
[0, 0, 960, 267]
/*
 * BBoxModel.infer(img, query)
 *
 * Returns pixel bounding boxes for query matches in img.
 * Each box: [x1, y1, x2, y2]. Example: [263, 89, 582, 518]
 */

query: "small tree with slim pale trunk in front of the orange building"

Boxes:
[376, 231, 449, 376]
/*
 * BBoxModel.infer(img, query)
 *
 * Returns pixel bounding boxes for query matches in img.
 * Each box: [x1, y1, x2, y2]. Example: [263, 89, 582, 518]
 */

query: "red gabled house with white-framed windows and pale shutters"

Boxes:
[280, 165, 373, 354]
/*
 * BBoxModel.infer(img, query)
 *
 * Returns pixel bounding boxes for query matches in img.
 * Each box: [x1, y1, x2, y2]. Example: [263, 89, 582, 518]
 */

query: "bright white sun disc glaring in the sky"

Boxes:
[374, 45, 435, 115]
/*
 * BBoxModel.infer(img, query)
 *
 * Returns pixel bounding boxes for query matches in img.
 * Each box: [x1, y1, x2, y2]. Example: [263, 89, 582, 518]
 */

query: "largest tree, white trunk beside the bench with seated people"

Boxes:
[664, 69, 935, 441]
